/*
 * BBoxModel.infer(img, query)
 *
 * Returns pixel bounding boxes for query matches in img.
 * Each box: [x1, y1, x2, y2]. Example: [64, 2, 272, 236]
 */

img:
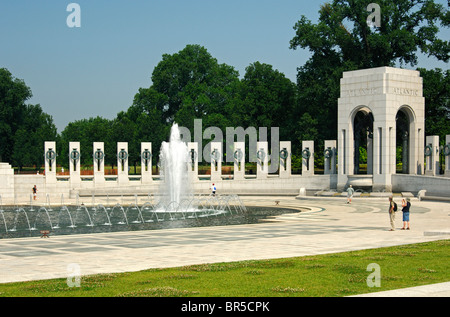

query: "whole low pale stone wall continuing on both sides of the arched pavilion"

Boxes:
[0, 168, 450, 204]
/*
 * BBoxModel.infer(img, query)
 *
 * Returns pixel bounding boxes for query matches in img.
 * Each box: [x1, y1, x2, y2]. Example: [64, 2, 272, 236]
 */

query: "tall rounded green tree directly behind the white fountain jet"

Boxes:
[131, 45, 239, 163]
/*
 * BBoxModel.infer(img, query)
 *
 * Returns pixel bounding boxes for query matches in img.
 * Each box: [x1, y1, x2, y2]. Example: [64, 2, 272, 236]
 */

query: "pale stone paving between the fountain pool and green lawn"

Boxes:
[0, 196, 450, 297]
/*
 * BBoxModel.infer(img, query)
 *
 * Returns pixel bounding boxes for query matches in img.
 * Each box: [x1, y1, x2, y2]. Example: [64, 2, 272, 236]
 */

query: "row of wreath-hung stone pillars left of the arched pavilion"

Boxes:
[45, 141, 342, 186]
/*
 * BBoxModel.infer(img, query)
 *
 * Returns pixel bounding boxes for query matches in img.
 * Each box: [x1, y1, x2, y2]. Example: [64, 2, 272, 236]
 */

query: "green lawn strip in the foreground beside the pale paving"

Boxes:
[0, 240, 450, 297]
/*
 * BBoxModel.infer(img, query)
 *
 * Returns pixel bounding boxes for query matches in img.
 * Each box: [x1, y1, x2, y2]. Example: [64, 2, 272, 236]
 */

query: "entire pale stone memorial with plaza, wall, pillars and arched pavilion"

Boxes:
[0, 67, 450, 296]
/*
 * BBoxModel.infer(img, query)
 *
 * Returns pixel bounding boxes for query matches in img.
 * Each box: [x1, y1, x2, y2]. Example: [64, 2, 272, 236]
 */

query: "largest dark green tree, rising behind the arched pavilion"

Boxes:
[290, 0, 450, 140]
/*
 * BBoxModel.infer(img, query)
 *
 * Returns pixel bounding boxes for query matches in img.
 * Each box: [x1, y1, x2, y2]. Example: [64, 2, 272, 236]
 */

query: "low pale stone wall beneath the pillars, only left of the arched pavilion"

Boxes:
[5, 175, 336, 202]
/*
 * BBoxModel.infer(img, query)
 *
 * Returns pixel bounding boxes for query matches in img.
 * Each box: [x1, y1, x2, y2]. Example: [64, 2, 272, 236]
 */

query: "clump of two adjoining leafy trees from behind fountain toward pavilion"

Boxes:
[125, 45, 296, 163]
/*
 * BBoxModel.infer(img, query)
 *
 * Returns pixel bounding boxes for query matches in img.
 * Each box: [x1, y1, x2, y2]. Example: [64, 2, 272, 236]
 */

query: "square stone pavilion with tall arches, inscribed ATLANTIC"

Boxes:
[337, 67, 425, 191]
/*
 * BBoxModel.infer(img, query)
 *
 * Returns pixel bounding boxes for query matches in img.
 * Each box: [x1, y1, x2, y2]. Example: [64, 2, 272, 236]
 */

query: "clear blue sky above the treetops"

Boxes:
[0, 0, 449, 132]
